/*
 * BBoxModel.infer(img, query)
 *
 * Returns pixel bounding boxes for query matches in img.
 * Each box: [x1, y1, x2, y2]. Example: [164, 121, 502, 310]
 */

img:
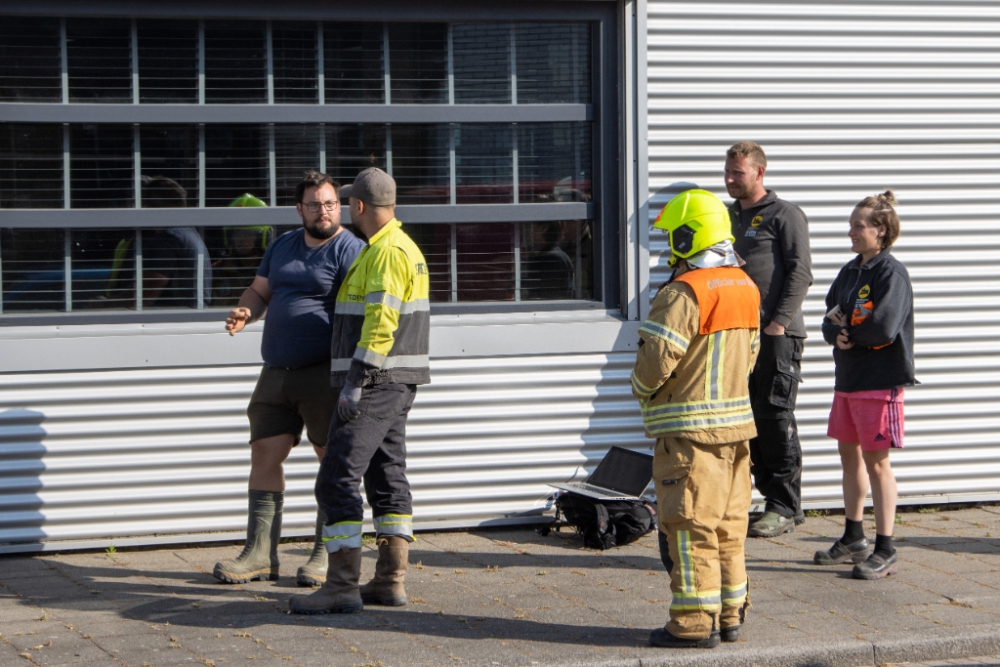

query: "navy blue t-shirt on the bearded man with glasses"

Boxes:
[257, 229, 365, 368]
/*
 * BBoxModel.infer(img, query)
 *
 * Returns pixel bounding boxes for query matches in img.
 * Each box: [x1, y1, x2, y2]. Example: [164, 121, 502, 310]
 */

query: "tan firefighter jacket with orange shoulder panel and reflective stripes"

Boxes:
[632, 267, 760, 444]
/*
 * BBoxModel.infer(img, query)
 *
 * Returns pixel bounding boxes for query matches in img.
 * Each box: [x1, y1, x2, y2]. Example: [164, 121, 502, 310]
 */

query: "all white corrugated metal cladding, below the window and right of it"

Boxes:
[0, 1, 1000, 552]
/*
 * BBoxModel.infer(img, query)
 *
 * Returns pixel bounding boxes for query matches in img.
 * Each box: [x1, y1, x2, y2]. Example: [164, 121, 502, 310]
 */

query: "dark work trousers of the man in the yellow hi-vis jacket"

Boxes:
[316, 383, 417, 526]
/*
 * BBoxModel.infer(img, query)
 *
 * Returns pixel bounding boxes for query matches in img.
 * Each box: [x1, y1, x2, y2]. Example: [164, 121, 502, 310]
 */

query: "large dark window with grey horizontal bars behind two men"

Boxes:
[0, 8, 617, 321]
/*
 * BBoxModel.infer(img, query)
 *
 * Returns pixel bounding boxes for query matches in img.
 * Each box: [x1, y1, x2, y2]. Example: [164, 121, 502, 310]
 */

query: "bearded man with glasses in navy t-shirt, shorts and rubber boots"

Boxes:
[213, 171, 365, 586]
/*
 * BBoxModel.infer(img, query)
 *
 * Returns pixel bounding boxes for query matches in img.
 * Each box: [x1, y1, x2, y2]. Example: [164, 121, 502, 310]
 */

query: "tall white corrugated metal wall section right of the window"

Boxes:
[648, 0, 1000, 506]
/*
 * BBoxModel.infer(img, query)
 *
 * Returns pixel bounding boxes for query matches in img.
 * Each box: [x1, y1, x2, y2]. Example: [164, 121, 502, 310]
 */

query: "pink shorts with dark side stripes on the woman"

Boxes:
[826, 389, 903, 452]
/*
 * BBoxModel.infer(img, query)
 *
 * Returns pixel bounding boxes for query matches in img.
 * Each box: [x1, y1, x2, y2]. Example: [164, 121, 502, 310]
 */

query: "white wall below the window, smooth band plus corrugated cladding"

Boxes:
[0, 311, 648, 553]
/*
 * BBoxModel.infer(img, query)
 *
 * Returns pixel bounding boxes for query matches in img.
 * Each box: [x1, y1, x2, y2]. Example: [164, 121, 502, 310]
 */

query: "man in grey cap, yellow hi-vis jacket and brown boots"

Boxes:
[289, 167, 430, 614]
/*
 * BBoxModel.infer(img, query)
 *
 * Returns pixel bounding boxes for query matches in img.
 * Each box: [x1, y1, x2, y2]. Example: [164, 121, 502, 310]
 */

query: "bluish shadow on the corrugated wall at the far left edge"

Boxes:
[0, 408, 47, 553]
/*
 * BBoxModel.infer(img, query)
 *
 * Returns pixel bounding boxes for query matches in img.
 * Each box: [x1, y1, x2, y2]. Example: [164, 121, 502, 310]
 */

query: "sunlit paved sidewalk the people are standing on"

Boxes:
[0, 506, 1000, 667]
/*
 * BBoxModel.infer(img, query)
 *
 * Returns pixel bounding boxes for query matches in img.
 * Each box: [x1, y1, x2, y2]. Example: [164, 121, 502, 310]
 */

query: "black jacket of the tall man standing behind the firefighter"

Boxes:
[729, 190, 812, 338]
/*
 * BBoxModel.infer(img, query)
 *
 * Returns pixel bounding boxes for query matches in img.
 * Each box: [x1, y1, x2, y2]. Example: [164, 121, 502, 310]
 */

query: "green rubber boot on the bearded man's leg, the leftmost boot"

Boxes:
[212, 489, 285, 584]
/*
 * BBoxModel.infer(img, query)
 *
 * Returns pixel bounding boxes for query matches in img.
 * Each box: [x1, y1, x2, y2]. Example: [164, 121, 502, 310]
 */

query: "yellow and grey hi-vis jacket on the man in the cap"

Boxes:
[330, 218, 430, 387]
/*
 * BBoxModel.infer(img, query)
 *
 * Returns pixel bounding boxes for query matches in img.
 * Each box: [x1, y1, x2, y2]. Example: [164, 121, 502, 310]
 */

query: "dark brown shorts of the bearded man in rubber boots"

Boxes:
[247, 361, 340, 447]
